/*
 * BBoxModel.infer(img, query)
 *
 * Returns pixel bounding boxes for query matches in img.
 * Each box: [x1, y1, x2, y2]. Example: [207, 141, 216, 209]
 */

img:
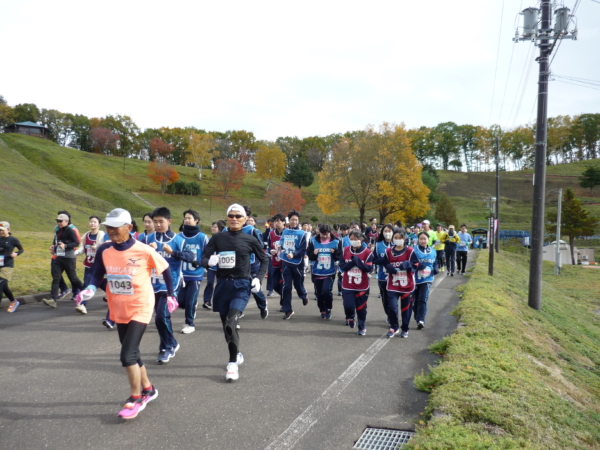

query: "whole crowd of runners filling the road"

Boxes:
[0, 208, 472, 419]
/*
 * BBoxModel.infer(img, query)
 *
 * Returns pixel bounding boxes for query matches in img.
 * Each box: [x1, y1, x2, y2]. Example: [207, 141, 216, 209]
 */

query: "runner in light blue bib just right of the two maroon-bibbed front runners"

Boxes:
[413, 231, 436, 330]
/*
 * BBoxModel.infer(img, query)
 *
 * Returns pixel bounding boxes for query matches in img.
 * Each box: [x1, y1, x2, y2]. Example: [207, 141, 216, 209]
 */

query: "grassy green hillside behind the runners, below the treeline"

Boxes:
[0, 134, 600, 231]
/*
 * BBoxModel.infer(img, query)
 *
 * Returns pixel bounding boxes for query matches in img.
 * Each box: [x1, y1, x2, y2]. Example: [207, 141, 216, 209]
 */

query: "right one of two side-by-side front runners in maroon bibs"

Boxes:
[382, 228, 419, 338]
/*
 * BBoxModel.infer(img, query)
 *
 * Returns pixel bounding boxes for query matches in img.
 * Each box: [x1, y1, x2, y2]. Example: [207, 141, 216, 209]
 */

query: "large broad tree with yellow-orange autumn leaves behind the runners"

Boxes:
[317, 123, 429, 222]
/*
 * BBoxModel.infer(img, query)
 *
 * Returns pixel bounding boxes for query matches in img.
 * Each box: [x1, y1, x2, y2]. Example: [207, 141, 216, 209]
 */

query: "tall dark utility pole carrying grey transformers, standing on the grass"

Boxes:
[514, 0, 577, 310]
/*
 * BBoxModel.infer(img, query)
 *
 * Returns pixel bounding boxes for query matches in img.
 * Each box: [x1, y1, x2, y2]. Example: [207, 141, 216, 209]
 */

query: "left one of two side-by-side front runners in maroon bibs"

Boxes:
[340, 228, 373, 336]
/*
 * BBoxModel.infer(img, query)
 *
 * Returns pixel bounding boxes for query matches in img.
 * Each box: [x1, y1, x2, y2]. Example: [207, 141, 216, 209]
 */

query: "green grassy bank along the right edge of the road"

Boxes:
[410, 252, 600, 450]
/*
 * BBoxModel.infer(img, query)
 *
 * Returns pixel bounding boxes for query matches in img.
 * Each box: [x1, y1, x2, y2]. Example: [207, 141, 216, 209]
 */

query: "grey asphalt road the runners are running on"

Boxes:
[0, 266, 466, 450]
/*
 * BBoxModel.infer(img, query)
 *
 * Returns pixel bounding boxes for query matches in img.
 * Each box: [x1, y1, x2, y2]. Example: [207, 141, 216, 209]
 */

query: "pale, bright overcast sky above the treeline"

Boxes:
[0, 0, 600, 140]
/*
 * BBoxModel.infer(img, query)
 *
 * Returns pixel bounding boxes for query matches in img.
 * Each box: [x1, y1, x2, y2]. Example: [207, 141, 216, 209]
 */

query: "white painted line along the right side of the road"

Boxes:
[265, 276, 446, 450]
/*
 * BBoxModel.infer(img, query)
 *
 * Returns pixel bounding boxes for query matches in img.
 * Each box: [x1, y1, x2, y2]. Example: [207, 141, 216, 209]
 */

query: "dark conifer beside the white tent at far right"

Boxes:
[546, 188, 600, 265]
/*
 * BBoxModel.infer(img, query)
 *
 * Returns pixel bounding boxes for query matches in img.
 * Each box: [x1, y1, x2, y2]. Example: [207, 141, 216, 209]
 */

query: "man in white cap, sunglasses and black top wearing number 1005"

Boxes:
[202, 203, 269, 381]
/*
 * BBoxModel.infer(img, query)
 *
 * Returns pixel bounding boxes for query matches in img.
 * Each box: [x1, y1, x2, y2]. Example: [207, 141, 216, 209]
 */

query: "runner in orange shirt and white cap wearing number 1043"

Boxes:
[77, 208, 171, 419]
